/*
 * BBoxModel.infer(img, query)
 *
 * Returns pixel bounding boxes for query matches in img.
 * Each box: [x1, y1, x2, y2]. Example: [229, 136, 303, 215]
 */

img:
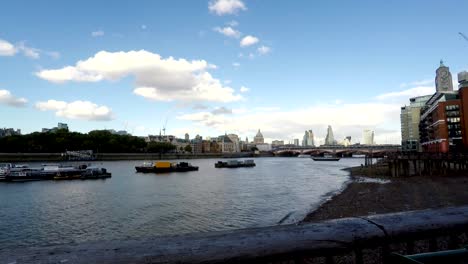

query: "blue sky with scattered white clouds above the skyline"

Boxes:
[0, 0, 468, 144]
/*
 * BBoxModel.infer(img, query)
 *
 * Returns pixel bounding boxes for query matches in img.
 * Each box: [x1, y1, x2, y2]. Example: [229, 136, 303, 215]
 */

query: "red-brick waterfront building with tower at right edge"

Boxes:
[419, 69, 468, 153]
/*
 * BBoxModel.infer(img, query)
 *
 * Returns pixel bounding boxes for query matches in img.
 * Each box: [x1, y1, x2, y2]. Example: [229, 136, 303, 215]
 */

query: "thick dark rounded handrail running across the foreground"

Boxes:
[0, 206, 468, 264]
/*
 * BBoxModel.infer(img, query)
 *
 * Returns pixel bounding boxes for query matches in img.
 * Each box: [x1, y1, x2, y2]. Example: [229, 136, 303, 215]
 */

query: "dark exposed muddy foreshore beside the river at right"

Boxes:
[303, 167, 468, 222]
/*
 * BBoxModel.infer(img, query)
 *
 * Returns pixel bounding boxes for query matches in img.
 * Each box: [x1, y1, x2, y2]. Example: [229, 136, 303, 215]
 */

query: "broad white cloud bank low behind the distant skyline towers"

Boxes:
[177, 103, 400, 143]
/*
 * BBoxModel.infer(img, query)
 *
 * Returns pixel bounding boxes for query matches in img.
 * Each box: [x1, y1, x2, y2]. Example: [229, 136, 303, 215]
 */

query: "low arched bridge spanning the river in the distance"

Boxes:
[272, 145, 401, 157]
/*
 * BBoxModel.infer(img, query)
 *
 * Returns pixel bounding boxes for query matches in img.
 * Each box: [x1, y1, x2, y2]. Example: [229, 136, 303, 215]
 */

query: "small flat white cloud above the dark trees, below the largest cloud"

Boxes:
[36, 100, 113, 121]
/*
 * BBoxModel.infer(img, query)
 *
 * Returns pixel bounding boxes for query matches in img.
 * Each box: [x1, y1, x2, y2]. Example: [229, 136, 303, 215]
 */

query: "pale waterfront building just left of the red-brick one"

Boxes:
[400, 95, 432, 152]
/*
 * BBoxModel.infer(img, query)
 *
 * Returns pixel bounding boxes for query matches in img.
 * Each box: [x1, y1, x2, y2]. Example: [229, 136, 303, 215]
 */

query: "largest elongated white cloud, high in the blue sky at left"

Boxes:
[36, 50, 243, 102]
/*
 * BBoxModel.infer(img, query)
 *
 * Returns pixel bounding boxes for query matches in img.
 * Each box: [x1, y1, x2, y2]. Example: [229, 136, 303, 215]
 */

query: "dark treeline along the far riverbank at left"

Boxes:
[0, 129, 175, 153]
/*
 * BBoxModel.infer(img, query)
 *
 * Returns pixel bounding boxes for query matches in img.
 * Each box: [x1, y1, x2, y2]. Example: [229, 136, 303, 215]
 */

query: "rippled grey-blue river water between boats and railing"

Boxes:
[0, 158, 363, 248]
